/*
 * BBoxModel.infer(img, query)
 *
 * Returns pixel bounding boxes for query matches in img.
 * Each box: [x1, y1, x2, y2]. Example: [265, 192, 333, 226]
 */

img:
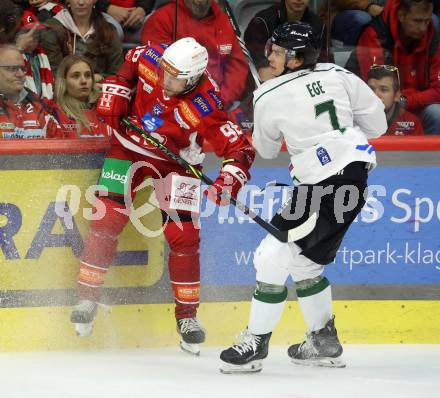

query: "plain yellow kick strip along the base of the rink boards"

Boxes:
[0, 300, 440, 352]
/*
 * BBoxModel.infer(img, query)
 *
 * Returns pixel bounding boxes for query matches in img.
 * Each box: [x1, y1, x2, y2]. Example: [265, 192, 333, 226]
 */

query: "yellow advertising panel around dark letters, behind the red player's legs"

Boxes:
[0, 169, 164, 290]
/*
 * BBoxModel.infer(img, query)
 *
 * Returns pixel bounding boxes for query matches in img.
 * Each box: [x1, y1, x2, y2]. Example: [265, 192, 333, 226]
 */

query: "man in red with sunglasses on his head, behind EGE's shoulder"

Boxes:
[367, 65, 424, 135]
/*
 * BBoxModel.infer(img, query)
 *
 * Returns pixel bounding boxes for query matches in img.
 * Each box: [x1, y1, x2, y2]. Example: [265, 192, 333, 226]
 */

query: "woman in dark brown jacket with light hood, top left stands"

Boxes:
[41, 0, 124, 82]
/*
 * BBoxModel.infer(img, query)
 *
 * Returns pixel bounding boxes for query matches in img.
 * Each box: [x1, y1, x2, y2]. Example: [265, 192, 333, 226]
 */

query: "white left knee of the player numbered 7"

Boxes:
[254, 235, 297, 285]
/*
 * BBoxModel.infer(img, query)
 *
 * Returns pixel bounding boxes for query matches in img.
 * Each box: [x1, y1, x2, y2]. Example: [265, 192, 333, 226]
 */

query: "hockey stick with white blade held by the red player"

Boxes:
[122, 118, 316, 242]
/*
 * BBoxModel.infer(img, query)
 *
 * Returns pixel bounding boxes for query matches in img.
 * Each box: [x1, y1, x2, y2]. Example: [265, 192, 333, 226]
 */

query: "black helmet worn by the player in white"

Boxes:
[265, 21, 320, 67]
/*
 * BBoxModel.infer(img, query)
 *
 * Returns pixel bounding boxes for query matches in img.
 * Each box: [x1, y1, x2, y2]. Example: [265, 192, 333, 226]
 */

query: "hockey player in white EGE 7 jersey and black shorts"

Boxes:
[220, 22, 387, 373]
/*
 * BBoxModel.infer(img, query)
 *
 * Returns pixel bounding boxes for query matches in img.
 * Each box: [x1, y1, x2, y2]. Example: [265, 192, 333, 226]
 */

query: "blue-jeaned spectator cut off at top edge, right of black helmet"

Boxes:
[319, 0, 386, 47]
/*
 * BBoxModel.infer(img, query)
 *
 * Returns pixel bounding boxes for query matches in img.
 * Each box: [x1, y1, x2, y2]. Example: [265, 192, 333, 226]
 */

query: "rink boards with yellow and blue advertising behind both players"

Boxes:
[0, 153, 440, 351]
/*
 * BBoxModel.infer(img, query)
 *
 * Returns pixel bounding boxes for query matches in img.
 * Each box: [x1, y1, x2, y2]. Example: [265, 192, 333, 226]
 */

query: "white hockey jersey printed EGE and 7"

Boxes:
[252, 63, 387, 184]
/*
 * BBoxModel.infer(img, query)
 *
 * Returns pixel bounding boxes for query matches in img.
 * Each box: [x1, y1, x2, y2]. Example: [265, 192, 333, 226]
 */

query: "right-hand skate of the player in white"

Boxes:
[287, 316, 345, 368]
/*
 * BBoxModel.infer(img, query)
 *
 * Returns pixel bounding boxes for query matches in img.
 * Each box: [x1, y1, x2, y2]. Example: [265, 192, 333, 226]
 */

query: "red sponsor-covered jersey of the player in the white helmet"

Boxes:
[98, 46, 254, 168]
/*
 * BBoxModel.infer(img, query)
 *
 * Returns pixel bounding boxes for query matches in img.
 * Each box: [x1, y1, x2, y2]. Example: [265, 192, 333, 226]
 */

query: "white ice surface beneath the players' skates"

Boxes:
[0, 345, 440, 398]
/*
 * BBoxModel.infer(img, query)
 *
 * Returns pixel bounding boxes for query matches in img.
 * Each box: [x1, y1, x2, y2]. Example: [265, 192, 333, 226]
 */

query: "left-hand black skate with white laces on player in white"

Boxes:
[220, 329, 272, 374]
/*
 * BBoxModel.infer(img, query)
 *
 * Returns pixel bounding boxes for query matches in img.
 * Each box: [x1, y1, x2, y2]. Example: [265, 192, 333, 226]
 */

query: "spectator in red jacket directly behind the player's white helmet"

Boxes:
[141, 0, 249, 109]
